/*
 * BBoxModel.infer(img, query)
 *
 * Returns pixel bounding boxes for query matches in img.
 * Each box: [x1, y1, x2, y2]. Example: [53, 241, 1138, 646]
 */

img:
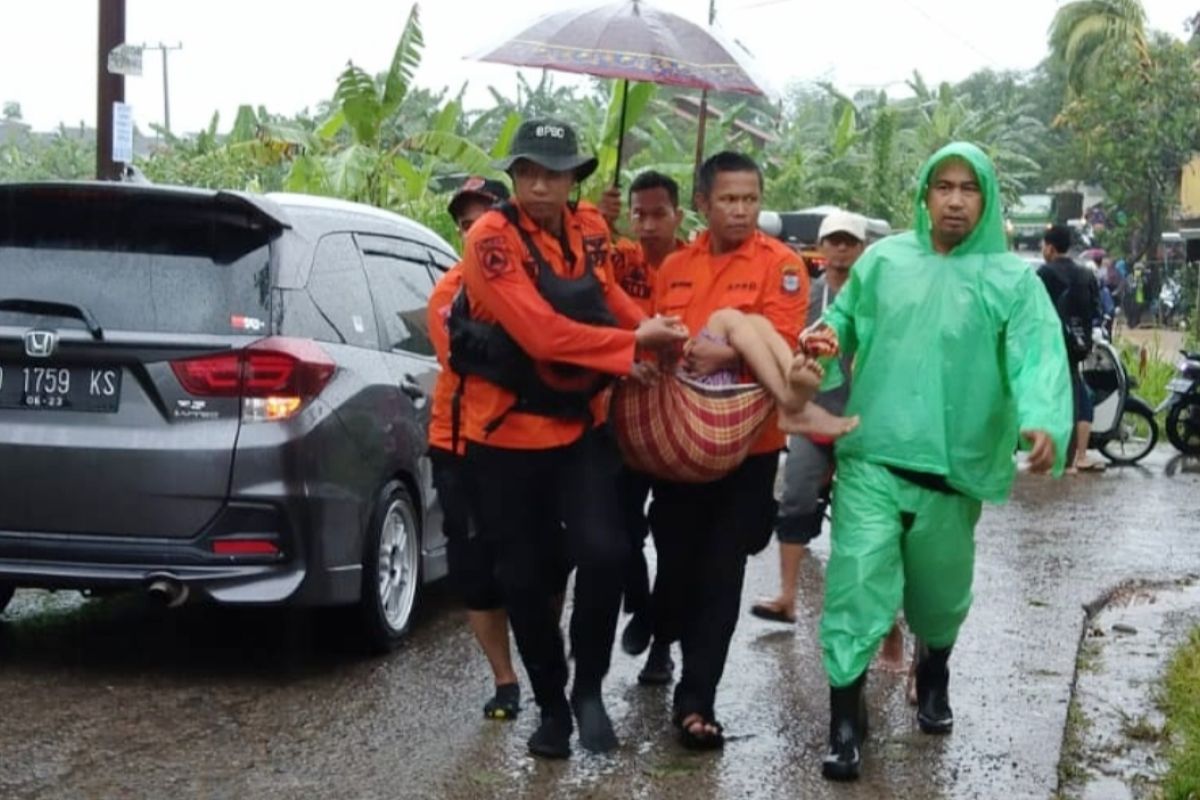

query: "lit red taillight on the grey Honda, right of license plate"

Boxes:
[170, 336, 337, 422]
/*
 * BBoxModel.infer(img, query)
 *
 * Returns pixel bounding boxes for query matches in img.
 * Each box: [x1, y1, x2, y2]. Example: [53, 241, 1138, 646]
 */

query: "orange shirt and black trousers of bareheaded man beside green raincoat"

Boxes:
[650, 227, 809, 718]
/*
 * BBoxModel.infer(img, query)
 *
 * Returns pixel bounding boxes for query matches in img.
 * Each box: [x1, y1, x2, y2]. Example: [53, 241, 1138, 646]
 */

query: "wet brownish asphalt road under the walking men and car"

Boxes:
[0, 449, 1200, 800]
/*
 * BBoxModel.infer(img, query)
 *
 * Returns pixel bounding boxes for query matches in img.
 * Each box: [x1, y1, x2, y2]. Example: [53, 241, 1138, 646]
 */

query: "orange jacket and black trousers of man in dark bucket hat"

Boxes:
[451, 205, 644, 714]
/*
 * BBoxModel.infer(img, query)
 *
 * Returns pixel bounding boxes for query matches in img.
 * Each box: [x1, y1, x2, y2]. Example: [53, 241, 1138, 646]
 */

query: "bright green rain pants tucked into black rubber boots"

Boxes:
[821, 458, 983, 687]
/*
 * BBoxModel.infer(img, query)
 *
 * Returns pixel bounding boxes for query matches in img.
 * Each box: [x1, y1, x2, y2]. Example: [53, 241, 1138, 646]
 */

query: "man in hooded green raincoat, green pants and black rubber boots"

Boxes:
[821, 143, 1072, 780]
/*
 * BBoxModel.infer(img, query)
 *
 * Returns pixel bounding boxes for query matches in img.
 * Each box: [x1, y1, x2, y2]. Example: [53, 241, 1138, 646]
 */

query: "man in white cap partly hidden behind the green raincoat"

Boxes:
[750, 211, 866, 624]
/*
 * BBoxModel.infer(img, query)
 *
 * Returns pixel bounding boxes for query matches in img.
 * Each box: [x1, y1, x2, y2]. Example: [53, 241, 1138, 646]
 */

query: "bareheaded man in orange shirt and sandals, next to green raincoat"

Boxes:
[649, 152, 809, 748]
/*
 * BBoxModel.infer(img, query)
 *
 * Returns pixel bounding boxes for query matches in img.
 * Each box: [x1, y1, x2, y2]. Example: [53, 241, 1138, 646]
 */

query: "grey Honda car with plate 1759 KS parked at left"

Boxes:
[0, 182, 456, 650]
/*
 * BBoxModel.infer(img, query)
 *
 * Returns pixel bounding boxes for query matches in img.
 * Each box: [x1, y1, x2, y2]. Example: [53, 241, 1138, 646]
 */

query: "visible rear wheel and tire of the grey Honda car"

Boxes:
[358, 481, 421, 654]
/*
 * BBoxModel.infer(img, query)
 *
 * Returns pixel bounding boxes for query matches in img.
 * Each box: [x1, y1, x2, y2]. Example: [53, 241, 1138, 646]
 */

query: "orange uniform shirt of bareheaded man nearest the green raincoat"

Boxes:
[654, 231, 809, 455]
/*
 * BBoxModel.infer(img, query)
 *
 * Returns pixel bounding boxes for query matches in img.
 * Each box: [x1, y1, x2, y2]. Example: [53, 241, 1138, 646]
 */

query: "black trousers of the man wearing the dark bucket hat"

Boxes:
[466, 429, 629, 712]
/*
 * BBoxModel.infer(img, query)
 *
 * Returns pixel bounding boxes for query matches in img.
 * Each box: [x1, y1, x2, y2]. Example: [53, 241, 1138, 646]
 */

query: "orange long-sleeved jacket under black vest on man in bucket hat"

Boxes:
[462, 204, 646, 450]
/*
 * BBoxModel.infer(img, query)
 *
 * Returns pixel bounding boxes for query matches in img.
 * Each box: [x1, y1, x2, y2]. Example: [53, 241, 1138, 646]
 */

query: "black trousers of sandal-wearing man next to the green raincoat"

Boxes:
[650, 453, 779, 717]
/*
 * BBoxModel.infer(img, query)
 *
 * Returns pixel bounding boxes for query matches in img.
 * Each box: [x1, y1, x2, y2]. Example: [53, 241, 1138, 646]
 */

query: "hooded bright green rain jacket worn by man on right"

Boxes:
[824, 143, 1073, 503]
